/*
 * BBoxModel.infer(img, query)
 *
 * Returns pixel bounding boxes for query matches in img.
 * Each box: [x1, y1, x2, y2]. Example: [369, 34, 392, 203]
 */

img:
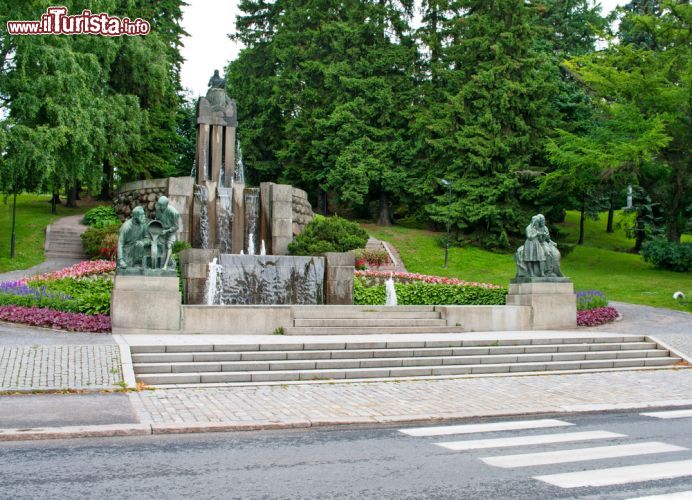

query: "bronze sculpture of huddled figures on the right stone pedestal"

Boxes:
[514, 214, 564, 279]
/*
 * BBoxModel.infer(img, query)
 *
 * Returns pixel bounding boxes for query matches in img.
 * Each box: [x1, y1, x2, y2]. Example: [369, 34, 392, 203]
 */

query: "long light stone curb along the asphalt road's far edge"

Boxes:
[0, 399, 692, 442]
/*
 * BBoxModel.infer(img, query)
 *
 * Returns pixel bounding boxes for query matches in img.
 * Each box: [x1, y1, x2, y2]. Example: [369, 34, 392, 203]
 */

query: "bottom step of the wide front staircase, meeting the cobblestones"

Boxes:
[137, 357, 680, 386]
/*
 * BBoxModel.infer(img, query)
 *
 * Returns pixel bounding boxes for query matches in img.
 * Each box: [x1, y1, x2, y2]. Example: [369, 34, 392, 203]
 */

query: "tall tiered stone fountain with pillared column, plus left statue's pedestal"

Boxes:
[112, 71, 353, 333]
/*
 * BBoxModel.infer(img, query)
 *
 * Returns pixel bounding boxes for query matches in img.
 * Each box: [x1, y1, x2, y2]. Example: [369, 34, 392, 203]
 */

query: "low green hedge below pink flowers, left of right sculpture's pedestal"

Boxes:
[353, 278, 507, 306]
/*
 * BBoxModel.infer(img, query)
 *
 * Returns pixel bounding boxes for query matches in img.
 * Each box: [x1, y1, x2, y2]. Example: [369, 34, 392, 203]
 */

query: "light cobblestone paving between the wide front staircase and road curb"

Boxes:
[129, 370, 692, 424]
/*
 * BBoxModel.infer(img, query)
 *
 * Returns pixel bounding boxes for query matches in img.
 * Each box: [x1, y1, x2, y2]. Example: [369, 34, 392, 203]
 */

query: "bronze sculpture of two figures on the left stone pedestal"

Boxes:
[117, 196, 180, 269]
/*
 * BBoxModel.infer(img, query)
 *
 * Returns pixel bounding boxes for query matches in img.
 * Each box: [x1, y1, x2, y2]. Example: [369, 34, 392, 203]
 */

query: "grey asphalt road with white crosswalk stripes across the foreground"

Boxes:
[0, 411, 692, 499]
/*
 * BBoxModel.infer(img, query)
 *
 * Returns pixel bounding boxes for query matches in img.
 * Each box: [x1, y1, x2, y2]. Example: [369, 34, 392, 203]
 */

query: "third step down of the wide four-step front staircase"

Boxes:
[134, 349, 669, 374]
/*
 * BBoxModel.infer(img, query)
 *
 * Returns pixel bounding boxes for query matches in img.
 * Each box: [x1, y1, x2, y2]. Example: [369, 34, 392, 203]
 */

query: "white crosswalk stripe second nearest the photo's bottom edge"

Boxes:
[534, 460, 692, 488]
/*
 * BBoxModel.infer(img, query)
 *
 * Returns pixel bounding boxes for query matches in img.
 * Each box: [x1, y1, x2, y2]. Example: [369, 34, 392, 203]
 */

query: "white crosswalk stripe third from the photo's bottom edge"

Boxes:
[481, 442, 687, 469]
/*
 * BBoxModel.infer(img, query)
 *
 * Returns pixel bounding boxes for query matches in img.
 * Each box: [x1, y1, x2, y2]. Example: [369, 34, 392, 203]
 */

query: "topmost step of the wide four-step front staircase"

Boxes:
[130, 335, 656, 354]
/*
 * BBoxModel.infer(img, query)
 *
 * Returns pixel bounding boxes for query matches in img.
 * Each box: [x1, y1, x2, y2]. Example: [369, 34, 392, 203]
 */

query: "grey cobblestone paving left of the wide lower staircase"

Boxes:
[0, 345, 122, 391]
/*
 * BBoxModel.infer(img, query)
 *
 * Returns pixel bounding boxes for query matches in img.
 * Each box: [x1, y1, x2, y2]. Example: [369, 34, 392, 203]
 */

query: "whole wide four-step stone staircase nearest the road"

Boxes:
[131, 334, 686, 387]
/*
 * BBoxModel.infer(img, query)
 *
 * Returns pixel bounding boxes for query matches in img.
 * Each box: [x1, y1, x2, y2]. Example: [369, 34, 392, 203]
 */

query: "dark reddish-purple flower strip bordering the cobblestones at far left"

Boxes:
[0, 306, 111, 333]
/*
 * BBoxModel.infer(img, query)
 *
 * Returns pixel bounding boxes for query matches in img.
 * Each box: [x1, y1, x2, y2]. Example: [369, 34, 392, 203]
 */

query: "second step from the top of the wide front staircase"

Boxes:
[132, 342, 665, 363]
